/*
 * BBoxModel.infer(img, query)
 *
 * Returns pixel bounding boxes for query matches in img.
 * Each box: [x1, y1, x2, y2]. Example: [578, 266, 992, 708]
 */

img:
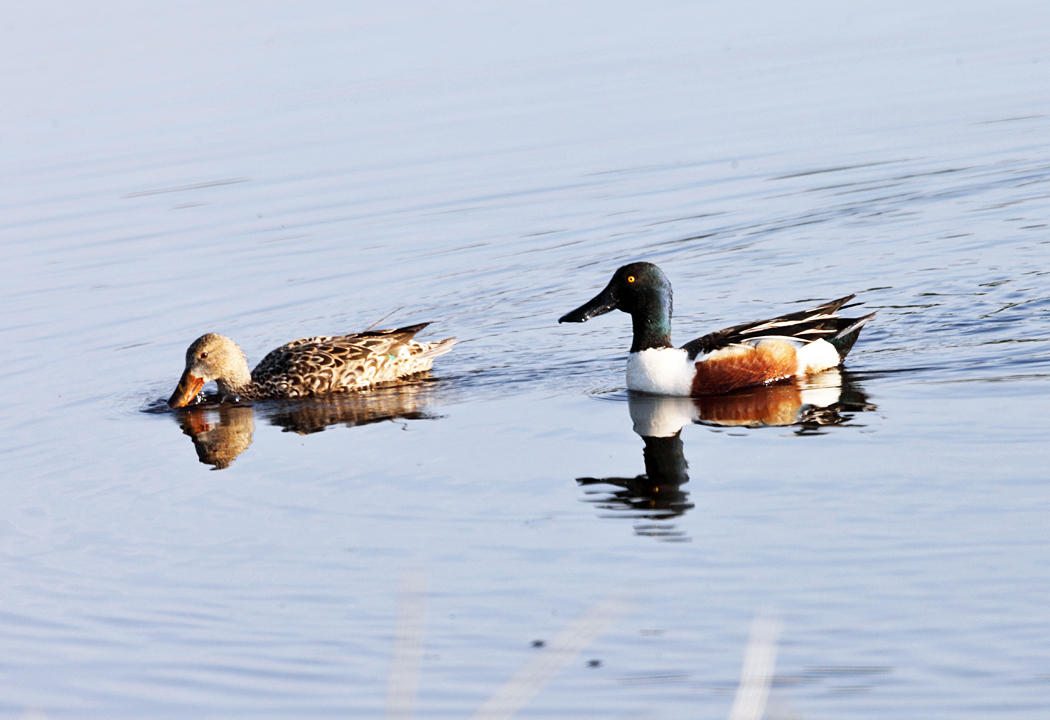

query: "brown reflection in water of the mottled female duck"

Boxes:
[175, 380, 438, 470]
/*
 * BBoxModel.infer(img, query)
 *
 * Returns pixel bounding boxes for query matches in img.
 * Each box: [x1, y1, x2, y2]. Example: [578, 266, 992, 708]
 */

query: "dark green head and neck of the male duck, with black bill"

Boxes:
[558, 262, 672, 353]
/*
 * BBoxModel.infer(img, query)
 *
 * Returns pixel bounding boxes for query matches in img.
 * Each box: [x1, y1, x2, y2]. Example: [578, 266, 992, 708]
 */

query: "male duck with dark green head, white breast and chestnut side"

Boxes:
[558, 262, 875, 396]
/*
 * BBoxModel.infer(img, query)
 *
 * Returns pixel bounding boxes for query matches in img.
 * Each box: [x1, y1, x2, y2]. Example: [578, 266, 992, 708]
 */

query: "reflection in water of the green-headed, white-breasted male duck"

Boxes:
[576, 369, 876, 542]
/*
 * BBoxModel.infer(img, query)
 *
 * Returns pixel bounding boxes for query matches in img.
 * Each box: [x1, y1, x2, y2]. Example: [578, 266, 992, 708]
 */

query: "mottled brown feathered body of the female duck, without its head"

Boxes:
[252, 323, 455, 398]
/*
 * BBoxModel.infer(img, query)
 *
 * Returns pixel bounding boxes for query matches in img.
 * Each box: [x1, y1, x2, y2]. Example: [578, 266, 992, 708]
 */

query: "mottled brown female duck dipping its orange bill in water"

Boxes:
[168, 322, 456, 407]
